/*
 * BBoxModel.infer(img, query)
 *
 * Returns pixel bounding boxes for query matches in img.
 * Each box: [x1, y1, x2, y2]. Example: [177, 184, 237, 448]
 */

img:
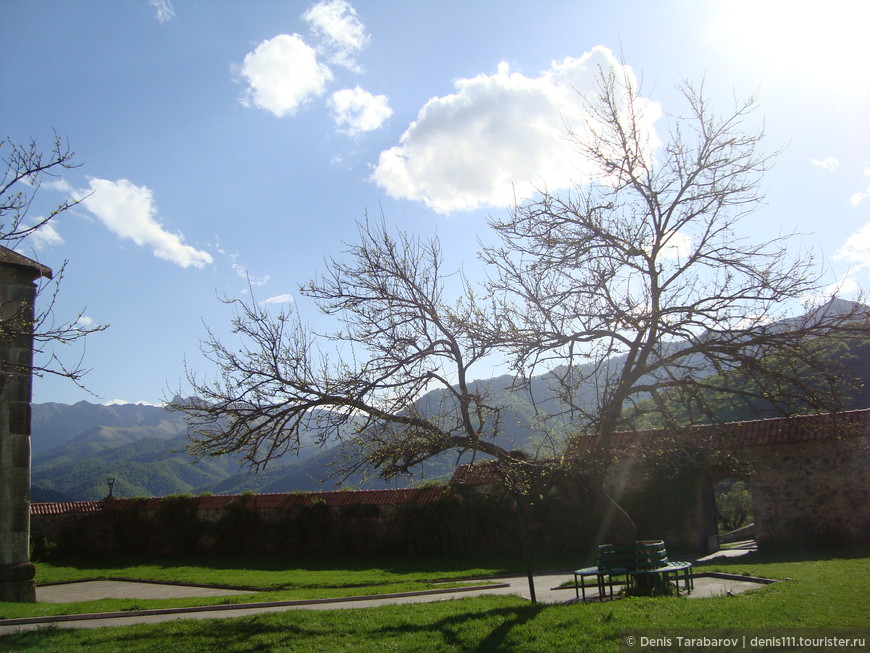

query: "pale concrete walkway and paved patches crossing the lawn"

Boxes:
[0, 571, 765, 635]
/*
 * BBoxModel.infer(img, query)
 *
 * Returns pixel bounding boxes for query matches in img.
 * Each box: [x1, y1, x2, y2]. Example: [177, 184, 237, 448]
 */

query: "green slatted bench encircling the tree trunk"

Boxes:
[574, 540, 694, 602]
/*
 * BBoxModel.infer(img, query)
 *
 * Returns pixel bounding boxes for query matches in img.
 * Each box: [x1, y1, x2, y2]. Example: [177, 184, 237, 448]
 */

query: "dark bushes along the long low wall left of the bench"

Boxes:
[32, 487, 620, 559]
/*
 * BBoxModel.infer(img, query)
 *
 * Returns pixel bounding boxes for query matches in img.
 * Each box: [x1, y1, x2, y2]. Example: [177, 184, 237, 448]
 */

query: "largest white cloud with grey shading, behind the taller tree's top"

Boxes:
[371, 46, 661, 213]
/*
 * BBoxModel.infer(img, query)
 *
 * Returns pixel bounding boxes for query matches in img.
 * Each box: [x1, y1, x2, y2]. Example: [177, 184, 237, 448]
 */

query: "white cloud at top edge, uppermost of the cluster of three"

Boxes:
[302, 0, 369, 72]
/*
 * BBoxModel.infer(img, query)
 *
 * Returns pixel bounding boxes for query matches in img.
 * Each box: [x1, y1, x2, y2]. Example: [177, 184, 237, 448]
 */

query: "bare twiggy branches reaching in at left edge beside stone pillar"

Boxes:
[0, 134, 108, 387]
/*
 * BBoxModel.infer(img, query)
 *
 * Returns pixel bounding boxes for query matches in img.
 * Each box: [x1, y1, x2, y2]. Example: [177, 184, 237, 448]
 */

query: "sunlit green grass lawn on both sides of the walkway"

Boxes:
[0, 555, 870, 653]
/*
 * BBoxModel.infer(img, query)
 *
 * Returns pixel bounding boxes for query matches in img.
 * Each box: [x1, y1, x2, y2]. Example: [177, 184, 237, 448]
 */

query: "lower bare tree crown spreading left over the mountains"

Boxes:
[174, 222, 532, 478]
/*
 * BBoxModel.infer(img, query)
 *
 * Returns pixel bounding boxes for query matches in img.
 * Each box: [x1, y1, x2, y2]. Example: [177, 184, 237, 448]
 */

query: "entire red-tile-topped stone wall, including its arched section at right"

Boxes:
[31, 410, 870, 564]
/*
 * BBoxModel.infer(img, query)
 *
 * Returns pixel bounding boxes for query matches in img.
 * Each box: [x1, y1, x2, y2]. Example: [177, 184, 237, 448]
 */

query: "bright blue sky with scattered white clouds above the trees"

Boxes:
[0, 0, 870, 404]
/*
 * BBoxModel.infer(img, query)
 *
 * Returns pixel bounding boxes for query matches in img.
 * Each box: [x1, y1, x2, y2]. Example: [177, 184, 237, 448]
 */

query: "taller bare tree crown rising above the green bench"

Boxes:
[484, 71, 868, 444]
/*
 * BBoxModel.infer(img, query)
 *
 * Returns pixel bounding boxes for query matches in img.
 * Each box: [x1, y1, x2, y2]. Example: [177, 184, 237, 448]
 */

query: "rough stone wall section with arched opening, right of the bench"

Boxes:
[615, 410, 870, 553]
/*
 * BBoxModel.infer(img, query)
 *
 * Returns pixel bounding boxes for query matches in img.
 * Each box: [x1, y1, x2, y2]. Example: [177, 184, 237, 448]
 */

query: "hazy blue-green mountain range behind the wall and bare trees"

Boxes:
[31, 304, 870, 502]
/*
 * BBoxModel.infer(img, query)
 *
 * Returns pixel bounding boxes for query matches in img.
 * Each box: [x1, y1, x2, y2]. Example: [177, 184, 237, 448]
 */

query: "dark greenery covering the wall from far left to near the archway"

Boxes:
[23, 472, 728, 560]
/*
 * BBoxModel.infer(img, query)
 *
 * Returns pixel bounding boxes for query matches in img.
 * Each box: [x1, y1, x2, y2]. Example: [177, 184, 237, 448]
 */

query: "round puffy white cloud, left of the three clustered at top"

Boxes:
[240, 34, 332, 118]
